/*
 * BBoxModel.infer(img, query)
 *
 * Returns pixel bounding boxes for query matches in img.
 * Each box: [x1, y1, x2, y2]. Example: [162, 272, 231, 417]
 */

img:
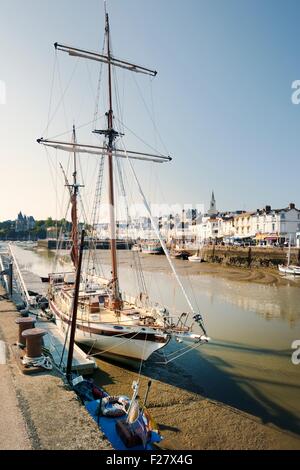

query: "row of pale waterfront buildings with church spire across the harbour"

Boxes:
[91, 198, 300, 245]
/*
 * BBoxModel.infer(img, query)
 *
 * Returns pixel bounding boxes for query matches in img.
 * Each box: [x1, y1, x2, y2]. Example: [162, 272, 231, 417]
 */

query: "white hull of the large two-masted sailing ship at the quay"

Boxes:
[50, 302, 170, 360]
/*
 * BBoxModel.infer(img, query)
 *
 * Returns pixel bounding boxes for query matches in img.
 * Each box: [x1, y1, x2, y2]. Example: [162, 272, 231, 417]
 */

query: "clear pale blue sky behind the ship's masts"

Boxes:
[0, 0, 300, 220]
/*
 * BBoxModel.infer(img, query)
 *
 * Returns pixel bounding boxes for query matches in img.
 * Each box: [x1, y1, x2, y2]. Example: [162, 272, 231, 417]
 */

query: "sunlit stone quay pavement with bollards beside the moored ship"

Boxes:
[0, 288, 111, 450]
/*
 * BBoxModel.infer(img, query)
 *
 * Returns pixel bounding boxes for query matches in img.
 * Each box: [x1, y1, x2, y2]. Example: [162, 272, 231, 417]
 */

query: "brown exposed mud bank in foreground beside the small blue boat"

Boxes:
[95, 360, 300, 450]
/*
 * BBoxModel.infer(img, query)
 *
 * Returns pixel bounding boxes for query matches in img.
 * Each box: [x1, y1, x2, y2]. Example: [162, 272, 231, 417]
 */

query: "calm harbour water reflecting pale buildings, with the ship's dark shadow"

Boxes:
[9, 246, 300, 435]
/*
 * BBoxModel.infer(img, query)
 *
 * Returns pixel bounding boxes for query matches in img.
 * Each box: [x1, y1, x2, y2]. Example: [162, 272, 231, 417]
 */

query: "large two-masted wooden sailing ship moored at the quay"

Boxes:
[37, 9, 209, 360]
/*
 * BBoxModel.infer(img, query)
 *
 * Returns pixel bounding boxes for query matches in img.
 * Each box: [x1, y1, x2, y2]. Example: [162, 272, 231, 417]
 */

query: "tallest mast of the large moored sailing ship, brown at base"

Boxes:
[105, 13, 121, 310]
